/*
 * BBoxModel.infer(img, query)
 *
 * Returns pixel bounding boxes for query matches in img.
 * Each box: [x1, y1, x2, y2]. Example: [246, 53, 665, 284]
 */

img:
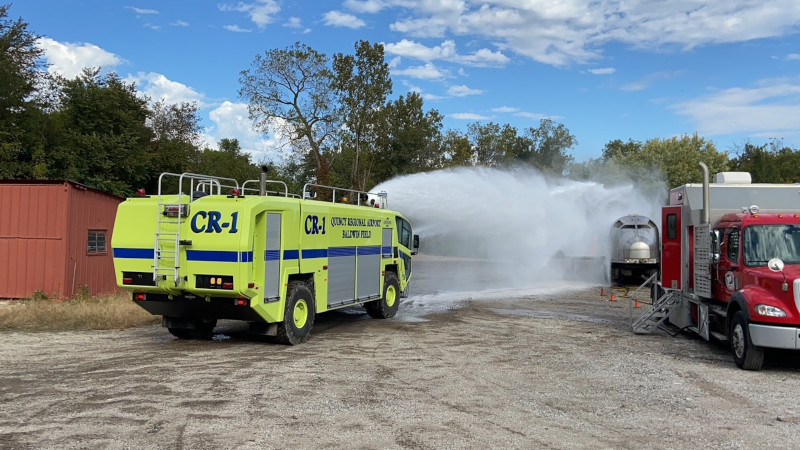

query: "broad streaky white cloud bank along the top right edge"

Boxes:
[386, 0, 800, 66]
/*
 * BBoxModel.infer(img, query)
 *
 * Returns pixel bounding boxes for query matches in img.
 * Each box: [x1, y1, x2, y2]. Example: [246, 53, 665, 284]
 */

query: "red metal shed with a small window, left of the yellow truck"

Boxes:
[0, 180, 123, 298]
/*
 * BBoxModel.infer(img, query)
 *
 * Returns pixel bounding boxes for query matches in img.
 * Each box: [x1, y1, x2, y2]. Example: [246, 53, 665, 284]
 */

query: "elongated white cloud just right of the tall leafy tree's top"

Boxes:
[383, 39, 510, 66]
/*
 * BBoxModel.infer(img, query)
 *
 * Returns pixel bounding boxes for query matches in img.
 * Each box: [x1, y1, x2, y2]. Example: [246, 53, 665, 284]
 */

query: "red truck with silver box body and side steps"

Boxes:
[633, 163, 800, 370]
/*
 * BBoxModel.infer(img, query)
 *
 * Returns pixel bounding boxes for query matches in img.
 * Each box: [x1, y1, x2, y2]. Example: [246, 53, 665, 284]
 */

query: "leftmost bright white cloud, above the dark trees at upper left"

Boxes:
[38, 37, 123, 78]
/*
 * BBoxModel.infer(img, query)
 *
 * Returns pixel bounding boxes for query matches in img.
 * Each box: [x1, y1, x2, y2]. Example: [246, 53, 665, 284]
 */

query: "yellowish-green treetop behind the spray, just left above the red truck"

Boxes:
[603, 134, 728, 188]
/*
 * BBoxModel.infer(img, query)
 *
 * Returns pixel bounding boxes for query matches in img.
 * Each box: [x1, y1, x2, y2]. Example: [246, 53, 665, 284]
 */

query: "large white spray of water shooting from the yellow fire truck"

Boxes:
[373, 167, 660, 295]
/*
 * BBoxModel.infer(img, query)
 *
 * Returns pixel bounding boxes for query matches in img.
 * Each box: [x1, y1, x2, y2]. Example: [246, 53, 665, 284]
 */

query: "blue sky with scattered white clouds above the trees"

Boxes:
[9, 0, 800, 161]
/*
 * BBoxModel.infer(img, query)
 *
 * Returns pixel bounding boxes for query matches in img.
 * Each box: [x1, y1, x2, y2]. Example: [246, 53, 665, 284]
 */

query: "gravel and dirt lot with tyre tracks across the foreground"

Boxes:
[0, 288, 800, 449]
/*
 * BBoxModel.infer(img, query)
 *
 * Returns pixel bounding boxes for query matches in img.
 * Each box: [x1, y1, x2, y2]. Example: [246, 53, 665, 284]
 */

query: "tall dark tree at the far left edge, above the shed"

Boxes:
[0, 5, 43, 178]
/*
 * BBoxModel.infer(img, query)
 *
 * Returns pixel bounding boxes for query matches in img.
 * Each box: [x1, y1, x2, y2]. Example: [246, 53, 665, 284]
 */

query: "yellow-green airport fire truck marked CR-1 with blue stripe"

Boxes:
[111, 173, 419, 344]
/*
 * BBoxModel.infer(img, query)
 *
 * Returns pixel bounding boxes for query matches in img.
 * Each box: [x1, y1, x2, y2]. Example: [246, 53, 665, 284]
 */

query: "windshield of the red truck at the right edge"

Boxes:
[744, 225, 800, 266]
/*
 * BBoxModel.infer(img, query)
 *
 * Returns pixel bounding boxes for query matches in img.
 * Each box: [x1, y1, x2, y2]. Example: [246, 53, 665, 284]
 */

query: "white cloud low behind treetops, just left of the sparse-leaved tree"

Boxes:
[206, 101, 285, 162]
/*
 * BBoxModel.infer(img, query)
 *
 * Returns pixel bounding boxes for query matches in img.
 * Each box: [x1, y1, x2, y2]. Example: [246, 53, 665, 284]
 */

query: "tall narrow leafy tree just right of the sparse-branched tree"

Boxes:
[333, 41, 392, 190]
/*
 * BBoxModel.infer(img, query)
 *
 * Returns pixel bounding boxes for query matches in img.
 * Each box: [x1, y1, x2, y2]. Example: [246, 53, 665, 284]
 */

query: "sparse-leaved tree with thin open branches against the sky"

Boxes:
[239, 42, 336, 184]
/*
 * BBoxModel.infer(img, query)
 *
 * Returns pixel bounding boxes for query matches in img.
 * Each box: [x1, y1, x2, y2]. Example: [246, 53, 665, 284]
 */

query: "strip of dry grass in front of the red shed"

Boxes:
[0, 294, 161, 331]
